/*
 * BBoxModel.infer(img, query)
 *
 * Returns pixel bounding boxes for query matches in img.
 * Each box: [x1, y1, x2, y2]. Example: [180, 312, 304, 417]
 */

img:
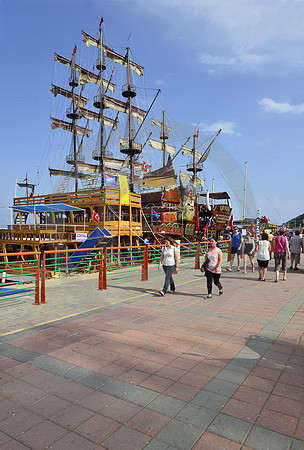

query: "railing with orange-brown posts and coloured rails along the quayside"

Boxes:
[0, 241, 230, 304]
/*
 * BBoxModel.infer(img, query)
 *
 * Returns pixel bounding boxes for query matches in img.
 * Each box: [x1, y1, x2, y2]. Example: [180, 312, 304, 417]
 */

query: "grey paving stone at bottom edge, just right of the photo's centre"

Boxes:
[155, 419, 202, 450]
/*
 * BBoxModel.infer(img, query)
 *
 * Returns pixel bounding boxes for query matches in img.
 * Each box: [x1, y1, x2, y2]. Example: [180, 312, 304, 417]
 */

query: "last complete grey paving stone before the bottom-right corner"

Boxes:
[207, 414, 251, 444]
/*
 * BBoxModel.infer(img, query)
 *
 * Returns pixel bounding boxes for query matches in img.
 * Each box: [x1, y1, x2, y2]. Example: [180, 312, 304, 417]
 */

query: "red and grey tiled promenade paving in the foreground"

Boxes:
[0, 262, 304, 450]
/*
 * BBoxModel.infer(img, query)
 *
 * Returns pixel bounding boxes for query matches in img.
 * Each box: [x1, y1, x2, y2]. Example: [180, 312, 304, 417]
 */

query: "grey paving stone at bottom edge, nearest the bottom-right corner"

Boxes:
[245, 425, 294, 450]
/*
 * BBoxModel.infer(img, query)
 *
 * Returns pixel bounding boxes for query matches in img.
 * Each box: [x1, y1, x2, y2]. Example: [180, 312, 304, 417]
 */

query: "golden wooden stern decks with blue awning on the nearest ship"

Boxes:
[0, 187, 142, 262]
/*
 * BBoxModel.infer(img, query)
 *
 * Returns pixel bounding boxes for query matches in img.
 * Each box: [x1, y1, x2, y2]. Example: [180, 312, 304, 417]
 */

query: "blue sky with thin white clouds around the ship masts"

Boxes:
[0, 0, 304, 225]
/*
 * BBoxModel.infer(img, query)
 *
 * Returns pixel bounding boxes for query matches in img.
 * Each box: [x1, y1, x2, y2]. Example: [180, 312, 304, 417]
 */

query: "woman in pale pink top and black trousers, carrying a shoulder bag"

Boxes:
[205, 238, 223, 298]
